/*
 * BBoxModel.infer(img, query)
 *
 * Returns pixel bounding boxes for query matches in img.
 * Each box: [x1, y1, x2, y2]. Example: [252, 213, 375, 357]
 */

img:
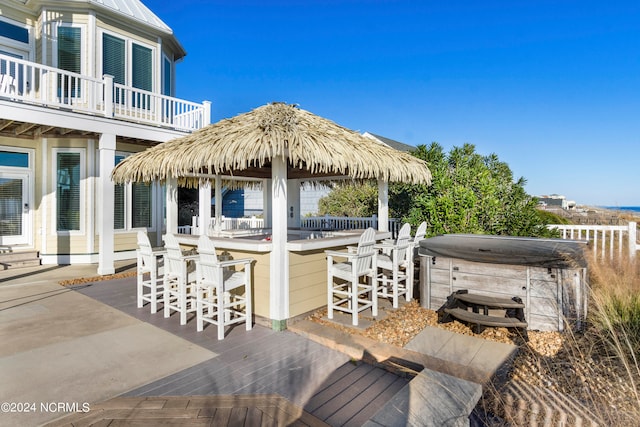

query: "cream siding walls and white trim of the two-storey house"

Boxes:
[0, 0, 198, 264]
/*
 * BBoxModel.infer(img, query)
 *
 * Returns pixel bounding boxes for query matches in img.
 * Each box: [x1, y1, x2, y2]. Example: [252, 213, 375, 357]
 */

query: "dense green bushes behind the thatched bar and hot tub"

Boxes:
[319, 143, 557, 237]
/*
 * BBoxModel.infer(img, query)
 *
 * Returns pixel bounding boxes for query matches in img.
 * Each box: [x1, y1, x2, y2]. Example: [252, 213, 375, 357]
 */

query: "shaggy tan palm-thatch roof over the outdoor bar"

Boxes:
[112, 103, 431, 184]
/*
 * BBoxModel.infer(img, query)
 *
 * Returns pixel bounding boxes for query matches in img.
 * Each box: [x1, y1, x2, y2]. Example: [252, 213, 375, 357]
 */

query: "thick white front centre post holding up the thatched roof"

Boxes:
[269, 155, 289, 331]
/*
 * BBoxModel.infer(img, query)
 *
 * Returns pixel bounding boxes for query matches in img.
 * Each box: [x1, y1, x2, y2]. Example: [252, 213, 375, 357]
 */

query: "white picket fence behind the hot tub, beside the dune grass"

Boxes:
[548, 222, 640, 259]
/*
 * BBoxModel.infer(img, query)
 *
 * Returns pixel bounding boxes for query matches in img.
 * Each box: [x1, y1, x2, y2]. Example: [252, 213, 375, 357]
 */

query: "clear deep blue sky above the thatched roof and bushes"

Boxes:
[143, 0, 640, 206]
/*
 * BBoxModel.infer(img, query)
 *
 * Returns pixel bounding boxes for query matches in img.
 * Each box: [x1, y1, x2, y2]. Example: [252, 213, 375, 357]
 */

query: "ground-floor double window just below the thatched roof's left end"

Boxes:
[113, 154, 153, 230]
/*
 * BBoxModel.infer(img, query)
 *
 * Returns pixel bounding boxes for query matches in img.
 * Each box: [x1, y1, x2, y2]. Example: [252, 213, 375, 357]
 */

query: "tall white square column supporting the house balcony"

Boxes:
[97, 134, 116, 275]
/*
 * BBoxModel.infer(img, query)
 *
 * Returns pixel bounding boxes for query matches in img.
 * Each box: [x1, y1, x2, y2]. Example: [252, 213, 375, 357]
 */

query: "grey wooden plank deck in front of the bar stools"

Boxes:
[67, 278, 407, 426]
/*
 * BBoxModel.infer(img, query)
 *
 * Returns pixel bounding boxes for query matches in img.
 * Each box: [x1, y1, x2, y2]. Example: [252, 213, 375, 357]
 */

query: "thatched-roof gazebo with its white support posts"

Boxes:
[112, 103, 431, 328]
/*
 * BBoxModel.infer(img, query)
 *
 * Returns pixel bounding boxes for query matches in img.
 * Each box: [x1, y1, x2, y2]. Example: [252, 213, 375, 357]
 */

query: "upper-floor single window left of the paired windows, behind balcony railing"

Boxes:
[58, 26, 82, 98]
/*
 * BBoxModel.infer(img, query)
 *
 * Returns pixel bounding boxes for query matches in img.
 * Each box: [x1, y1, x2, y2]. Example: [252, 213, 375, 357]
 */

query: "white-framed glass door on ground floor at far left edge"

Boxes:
[0, 172, 30, 245]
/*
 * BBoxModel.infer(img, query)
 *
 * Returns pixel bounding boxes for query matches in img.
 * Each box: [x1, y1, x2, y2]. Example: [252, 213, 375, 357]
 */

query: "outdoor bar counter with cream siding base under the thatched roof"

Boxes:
[177, 229, 391, 326]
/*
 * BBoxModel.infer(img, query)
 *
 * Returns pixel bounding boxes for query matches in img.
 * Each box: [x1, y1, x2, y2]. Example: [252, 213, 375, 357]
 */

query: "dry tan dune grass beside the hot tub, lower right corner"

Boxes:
[483, 259, 640, 427]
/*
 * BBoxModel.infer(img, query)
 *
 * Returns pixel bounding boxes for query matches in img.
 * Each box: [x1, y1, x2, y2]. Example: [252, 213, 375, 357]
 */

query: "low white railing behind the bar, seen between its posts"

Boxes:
[178, 215, 399, 236]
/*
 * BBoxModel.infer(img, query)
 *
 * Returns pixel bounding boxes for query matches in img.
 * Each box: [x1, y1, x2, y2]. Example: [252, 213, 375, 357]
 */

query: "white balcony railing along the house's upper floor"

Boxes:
[0, 55, 211, 132]
